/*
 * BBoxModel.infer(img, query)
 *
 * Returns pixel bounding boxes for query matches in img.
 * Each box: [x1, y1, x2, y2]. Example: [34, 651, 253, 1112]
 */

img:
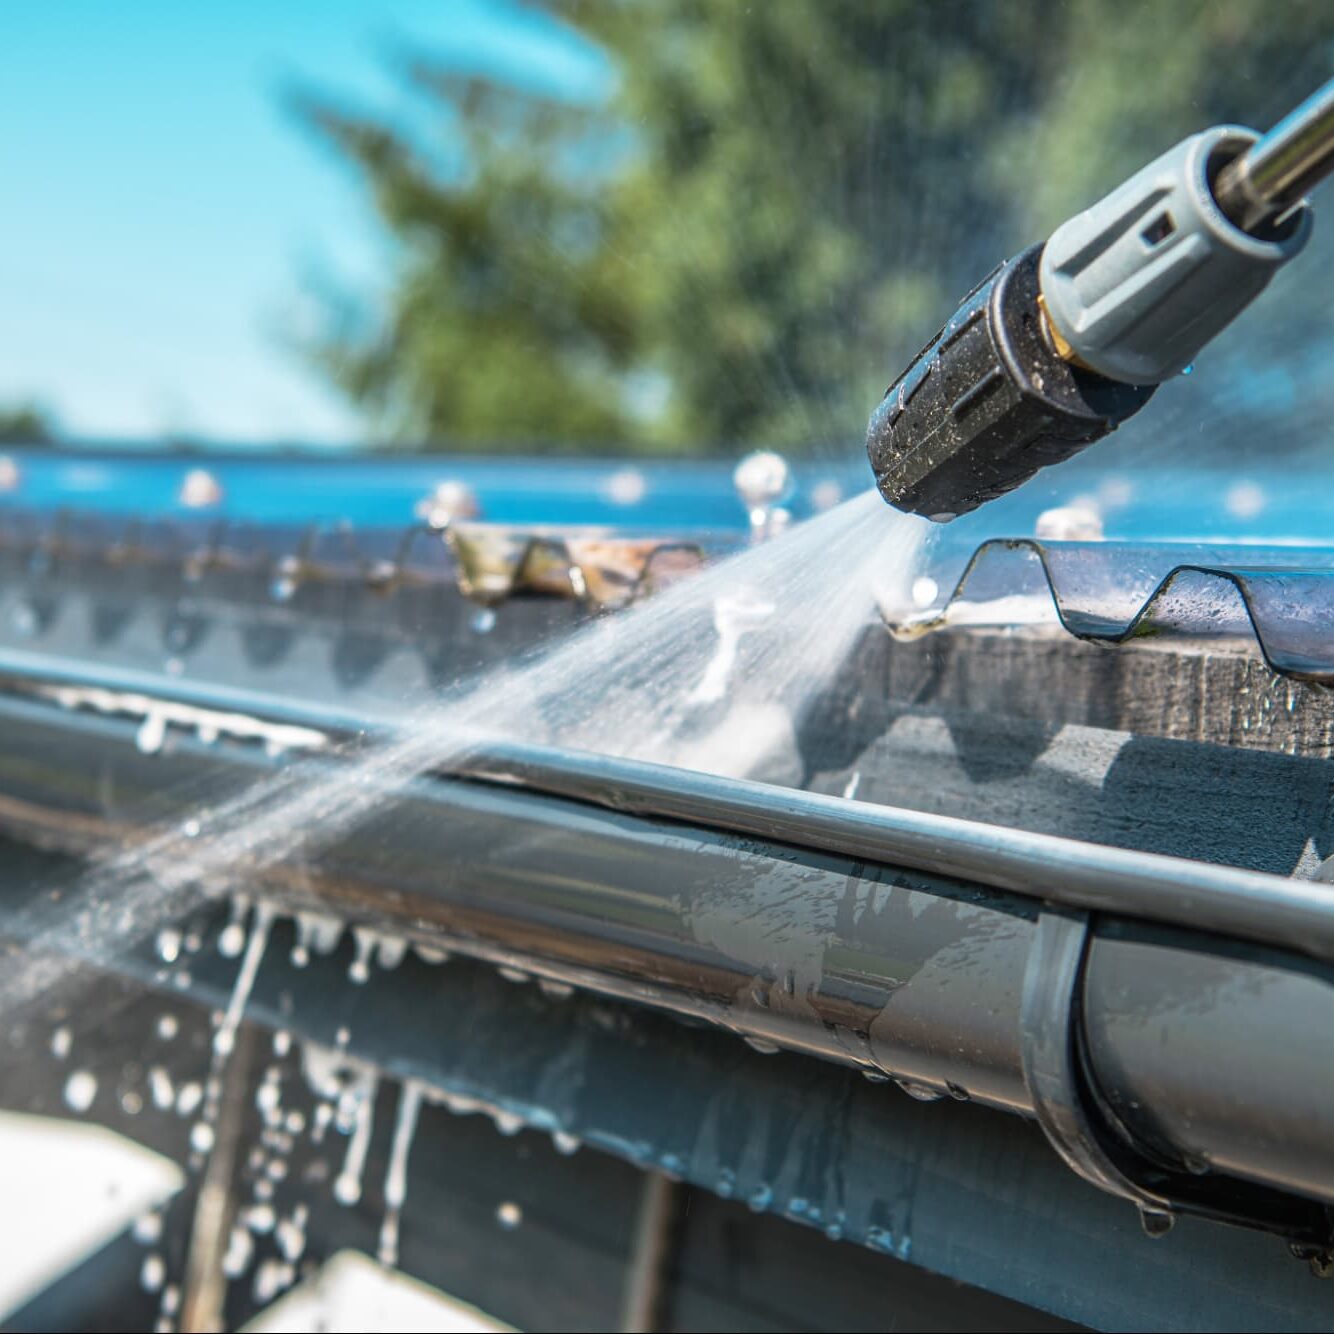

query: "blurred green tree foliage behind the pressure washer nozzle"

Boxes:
[300, 0, 1334, 452]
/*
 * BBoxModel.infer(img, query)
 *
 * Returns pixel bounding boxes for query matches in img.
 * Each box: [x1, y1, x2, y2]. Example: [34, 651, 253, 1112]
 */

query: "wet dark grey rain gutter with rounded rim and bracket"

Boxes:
[0, 677, 1334, 1249]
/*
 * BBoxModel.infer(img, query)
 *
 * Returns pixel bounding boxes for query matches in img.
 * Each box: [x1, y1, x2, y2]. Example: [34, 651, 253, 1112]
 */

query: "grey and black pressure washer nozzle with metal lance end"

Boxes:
[866, 80, 1334, 522]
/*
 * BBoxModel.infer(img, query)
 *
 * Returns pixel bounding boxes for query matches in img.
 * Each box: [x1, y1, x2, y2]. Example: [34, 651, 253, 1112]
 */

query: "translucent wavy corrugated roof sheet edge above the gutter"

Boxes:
[0, 508, 1334, 684]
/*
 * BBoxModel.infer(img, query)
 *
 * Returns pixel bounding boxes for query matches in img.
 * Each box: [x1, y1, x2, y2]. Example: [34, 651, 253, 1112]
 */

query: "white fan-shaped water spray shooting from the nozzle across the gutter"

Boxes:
[0, 492, 927, 1006]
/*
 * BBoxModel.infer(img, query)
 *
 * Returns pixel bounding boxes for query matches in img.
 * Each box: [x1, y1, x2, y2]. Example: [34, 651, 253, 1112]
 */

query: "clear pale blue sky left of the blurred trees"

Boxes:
[0, 0, 607, 442]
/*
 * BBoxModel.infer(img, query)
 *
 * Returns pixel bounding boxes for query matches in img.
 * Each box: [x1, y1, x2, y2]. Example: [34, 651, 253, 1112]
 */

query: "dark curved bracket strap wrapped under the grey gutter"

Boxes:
[1021, 904, 1334, 1253]
